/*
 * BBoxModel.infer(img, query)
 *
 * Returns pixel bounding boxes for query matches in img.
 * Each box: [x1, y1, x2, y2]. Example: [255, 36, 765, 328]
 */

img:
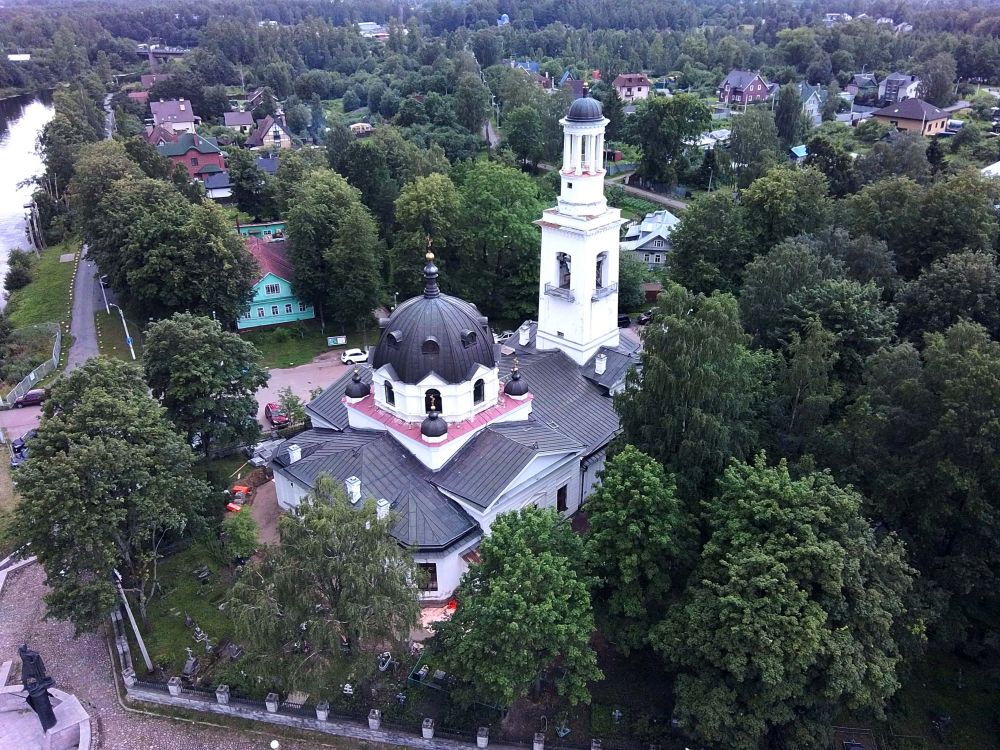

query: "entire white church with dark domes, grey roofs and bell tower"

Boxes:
[273, 96, 639, 605]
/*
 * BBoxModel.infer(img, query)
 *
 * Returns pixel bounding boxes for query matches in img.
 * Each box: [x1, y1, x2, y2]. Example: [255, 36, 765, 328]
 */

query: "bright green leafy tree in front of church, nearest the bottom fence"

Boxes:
[434, 506, 603, 706]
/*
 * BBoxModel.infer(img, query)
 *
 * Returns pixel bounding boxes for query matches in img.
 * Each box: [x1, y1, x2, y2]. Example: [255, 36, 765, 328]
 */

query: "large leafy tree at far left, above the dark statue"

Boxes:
[15, 358, 215, 633]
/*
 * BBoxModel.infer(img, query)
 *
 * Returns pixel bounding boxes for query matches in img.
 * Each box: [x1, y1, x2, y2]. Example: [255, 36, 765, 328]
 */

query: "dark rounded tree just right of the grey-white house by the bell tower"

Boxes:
[667, 191, 753, 294]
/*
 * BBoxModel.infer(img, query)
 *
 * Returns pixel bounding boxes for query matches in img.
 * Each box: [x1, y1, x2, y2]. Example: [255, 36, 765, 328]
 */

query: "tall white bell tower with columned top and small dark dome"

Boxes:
[535, 95, 622, 365]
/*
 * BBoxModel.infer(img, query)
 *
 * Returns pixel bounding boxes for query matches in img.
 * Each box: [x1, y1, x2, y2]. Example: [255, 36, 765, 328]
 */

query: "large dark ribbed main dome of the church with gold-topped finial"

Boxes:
[372, 253, 496, 384]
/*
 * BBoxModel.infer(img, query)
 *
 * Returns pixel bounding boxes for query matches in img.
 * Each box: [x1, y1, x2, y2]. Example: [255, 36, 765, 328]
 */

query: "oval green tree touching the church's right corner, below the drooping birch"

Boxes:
[586, 445, 696, 654]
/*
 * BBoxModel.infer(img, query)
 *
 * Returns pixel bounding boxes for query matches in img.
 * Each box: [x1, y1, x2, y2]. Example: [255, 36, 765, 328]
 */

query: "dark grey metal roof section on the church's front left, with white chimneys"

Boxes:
[274, 428, 479, 550]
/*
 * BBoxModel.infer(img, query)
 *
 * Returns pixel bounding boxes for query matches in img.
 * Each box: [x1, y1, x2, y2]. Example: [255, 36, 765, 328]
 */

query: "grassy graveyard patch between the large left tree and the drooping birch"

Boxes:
[143, 544, 233, 675]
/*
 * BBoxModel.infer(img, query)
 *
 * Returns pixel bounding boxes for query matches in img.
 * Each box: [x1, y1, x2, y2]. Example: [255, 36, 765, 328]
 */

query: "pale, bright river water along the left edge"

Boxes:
[0, 94, 55, 309]
